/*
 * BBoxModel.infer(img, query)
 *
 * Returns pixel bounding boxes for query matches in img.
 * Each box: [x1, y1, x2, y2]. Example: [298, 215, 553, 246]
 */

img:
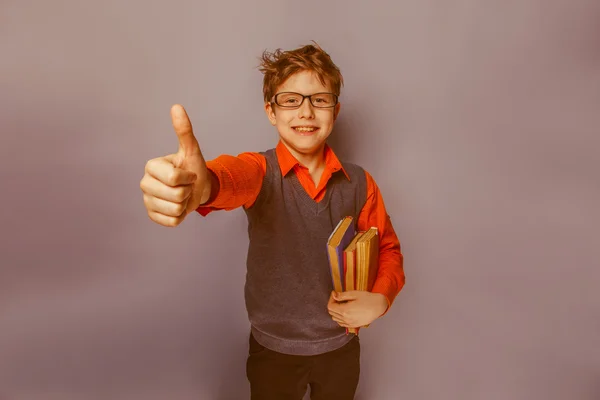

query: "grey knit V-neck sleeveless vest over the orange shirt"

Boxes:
[244, 149, 367, 355]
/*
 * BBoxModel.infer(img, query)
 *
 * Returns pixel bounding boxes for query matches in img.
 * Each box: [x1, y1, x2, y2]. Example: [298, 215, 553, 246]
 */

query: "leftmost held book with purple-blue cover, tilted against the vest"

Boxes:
[327, 217, 356, 292]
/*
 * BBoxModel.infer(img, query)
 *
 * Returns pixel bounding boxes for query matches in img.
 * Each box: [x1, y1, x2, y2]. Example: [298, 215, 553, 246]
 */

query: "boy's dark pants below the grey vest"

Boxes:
[246, 334, 360, 400]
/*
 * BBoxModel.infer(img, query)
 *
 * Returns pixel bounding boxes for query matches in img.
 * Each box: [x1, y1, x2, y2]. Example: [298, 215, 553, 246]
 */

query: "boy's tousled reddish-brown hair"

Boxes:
[259, 41, 344, 102]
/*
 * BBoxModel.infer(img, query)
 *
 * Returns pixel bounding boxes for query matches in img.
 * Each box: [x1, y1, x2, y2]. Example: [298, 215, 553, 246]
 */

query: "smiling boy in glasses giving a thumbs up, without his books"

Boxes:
[140, 45, 405, 400]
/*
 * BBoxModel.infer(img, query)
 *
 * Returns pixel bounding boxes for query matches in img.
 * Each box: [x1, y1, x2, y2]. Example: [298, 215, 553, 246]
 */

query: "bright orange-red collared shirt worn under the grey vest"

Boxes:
[197, 141, 405, 312]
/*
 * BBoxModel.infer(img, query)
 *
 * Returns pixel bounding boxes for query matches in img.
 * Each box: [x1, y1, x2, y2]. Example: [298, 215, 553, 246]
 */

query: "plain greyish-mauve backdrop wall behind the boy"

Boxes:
[0, 0, 600, 400]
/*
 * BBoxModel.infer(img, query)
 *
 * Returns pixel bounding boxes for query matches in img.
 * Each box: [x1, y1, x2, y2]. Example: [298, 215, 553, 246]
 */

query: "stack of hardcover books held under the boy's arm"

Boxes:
[327, 217, 379, 334]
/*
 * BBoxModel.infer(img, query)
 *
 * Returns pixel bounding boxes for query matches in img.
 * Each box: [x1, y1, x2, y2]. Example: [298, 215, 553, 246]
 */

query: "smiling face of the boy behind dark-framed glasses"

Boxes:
[265, 71, 340, 156]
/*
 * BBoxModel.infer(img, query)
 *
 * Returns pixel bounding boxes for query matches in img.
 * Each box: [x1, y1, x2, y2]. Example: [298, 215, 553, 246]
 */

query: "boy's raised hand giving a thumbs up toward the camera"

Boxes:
[140, 105, 212, 227]
